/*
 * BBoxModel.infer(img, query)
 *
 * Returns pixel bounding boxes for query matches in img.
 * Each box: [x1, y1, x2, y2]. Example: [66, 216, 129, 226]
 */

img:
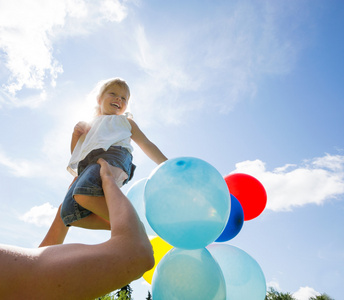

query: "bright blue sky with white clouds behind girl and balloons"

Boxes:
[0, 0, 344, 300]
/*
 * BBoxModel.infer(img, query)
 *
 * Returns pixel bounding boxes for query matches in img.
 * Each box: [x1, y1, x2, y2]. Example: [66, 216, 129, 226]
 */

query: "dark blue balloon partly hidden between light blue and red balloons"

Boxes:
[215, 195, 244, 242]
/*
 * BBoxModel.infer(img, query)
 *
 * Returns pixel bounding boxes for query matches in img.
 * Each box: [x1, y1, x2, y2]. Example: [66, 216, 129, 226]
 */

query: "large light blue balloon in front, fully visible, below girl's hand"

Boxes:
[144, 157, 230, 249]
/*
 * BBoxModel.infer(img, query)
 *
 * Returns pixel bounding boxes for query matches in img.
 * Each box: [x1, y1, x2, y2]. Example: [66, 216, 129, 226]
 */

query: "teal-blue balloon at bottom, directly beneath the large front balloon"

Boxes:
[152, 248, 226, 300]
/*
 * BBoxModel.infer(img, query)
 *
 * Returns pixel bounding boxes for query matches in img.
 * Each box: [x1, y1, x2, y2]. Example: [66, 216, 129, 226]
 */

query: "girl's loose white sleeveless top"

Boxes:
[67, 115, 133, 176]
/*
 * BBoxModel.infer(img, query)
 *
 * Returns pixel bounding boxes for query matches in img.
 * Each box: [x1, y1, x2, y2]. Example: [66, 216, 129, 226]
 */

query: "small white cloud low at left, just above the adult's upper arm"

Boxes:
[19, 202, 57, 227]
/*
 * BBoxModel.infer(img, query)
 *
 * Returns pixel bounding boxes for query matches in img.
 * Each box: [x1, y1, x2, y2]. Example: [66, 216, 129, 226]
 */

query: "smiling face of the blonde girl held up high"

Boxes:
[98, 84, 129, 115]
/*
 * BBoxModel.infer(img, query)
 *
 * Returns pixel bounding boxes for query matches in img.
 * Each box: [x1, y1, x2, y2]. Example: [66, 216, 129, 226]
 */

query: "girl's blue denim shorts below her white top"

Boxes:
[61, 146, 136, 226]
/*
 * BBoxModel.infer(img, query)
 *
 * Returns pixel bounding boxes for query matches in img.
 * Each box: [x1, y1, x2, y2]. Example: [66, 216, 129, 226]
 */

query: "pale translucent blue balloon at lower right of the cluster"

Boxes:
[207, 244, 266, 300]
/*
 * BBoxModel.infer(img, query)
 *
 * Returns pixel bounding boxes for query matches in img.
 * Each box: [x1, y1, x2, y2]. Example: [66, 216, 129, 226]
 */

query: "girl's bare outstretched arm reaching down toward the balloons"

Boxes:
[128, 119, 167, 164]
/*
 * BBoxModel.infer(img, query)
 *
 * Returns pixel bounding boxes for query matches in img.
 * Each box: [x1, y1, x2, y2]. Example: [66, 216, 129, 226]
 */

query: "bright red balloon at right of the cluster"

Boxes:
[224, 173, 267, 221]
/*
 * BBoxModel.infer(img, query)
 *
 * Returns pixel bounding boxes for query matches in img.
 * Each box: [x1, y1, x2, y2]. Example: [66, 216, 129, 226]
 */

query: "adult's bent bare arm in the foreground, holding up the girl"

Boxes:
[0, 160, 154, 300]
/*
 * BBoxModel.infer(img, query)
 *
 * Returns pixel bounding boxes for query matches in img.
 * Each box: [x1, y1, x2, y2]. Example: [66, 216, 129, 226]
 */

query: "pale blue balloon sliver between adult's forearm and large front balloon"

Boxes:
[127, 178, 157, 236]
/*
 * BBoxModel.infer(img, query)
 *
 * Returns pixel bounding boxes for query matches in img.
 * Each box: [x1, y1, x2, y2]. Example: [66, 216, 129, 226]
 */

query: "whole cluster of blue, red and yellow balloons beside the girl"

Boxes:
[127, 157, 267, 300]
